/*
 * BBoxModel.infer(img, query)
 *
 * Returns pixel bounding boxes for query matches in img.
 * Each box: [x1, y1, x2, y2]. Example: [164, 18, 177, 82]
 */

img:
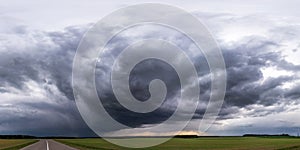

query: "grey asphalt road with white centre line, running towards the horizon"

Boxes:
[21, 140, 77, 150]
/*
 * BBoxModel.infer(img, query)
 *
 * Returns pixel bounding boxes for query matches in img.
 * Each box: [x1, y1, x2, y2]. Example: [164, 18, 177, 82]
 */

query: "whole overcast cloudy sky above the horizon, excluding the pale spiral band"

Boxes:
[0, 0, 300, 136]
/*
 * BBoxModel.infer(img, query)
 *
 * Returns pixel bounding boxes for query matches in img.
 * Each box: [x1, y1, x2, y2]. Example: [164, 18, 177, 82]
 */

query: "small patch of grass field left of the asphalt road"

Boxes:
[0, 139, 38, 150]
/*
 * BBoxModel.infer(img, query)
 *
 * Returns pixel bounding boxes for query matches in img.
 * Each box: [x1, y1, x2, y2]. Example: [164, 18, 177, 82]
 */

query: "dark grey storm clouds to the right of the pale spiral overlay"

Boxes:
[212, 37, 300, 119]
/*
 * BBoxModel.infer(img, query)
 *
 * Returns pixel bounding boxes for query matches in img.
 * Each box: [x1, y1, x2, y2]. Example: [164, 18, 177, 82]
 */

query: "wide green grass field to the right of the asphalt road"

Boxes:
[57, 137, 300, 150]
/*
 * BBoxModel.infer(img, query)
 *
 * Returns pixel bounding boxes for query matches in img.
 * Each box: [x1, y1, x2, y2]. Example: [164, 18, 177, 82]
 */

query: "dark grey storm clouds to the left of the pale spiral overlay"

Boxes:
[0, 24, 94, 136]
